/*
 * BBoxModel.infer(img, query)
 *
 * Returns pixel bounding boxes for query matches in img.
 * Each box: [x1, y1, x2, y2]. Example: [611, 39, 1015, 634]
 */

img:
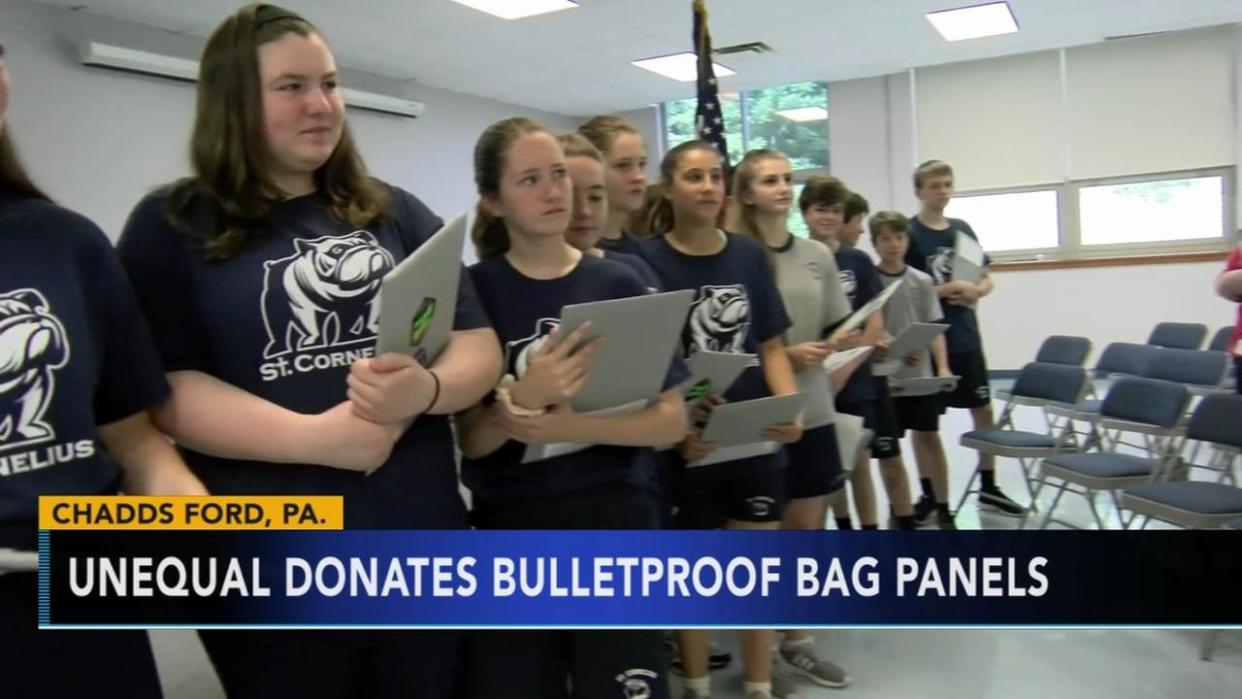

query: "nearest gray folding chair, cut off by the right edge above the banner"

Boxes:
[1122, 394, 1242, 529]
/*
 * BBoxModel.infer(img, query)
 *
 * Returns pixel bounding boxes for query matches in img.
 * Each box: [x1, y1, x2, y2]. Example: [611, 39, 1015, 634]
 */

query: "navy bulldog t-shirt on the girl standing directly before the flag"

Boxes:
[641, 233, 790, 401]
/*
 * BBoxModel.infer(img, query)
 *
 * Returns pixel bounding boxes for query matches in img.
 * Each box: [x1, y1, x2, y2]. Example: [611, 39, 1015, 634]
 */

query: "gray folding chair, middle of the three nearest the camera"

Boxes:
[1035, 379, 1190, 529]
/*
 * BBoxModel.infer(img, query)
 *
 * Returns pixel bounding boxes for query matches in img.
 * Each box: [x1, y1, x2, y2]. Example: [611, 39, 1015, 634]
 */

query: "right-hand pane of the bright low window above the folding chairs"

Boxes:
[1078, 175, 1225, 246]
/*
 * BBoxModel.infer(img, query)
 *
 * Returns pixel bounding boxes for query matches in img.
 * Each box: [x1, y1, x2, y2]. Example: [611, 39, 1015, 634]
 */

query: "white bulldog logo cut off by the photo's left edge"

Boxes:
[0, 289, 70, 451]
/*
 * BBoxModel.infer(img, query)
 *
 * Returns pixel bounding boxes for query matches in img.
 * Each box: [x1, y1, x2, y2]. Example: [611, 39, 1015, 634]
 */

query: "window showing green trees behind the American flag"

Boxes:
[662, 82, 828, 171]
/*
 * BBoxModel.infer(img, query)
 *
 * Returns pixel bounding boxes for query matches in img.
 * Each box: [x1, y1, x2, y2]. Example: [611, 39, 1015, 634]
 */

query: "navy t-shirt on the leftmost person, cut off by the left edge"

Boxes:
[0, 192, 168, 548]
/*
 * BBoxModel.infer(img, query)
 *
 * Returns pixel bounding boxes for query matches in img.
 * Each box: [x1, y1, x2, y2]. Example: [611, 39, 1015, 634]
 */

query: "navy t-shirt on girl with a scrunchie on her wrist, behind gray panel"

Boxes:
[462, 255, 687, 503]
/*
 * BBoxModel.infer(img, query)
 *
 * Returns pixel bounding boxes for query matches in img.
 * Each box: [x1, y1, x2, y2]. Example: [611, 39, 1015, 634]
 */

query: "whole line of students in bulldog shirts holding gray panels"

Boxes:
[0, 4, 1022, 699]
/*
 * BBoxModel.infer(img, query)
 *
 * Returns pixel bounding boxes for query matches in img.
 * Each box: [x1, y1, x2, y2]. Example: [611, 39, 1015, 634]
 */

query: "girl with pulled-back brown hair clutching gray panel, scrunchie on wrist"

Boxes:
[458, 118, 686, 699]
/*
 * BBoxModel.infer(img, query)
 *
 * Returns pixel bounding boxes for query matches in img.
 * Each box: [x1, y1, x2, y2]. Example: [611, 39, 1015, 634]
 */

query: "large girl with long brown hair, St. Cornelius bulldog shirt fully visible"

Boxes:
[119, 5, 499, 697]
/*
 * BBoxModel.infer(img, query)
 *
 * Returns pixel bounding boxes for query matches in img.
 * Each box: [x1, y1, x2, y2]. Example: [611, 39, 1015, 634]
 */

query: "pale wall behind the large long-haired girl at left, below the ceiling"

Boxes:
[0, 0, 578, 243]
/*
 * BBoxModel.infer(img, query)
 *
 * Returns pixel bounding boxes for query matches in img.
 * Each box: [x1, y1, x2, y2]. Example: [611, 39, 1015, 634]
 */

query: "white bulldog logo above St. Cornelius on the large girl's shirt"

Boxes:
[261, 231, 394, 359]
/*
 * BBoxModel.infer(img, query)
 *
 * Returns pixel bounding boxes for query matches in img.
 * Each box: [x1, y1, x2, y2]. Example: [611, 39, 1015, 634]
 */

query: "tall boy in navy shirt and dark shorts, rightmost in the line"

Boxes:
[905, 160, 1026, 518]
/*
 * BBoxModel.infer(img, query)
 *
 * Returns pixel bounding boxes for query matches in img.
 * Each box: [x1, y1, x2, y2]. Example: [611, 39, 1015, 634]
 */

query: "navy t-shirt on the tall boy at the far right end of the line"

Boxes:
[905, 216, 991, 354]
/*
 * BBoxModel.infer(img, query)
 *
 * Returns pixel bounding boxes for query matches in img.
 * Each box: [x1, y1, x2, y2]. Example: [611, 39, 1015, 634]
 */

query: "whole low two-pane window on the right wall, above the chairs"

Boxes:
[945, 168, 1233, 261]
